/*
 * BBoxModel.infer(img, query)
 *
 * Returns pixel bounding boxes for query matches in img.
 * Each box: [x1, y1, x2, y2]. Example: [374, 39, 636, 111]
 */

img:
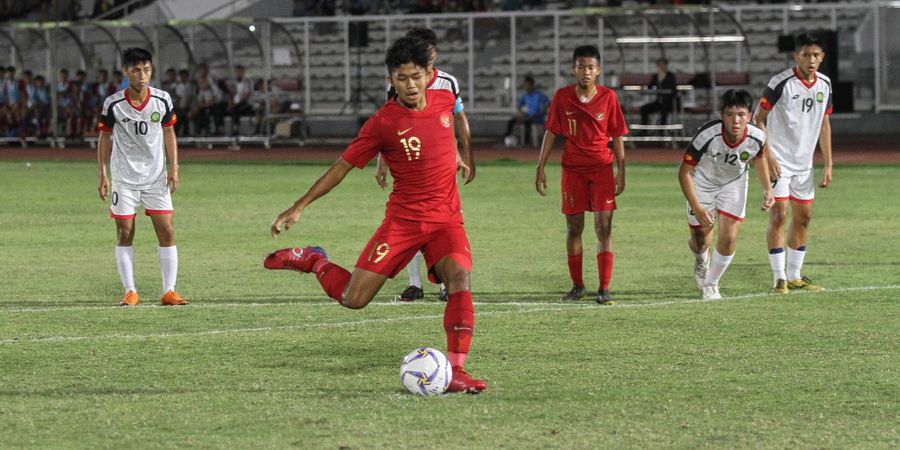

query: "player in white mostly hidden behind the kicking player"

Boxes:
[375, 28, 475, 302]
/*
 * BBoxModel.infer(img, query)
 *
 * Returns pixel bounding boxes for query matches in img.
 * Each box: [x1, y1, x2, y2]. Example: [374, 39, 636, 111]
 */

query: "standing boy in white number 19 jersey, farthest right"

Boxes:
[756, 34, 832, 294]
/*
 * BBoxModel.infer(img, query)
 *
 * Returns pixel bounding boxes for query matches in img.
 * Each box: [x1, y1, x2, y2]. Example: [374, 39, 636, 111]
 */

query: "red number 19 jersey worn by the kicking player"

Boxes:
[341, 89, 462, 223]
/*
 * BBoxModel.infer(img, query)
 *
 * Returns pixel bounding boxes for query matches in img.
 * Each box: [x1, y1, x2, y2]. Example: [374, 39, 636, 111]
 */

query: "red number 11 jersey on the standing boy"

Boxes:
[546, 84, 628, 172]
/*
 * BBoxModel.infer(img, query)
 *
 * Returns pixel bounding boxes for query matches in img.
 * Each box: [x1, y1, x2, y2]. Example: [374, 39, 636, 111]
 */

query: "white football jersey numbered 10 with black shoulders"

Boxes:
[97, 87, 178, 190]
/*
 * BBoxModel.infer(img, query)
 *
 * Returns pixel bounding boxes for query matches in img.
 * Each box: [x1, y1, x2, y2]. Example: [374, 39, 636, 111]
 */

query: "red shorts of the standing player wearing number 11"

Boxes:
[562, 164, 616, 214]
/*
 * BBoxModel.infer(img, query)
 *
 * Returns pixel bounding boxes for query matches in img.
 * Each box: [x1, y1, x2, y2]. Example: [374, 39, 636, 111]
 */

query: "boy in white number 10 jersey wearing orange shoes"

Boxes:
[97, 48, 188, 306]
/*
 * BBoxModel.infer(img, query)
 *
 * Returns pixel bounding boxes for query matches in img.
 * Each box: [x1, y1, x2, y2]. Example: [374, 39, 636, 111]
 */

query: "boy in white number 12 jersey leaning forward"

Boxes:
[678, 89, 775, 300]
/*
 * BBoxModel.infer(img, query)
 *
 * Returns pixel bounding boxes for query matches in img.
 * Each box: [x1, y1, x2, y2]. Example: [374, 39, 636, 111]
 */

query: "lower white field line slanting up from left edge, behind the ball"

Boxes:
[0, 285, 900, 345]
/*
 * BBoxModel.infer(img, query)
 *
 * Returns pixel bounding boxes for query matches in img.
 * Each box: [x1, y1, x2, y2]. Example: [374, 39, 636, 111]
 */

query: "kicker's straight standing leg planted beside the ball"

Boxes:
[425, 224, 487, 394]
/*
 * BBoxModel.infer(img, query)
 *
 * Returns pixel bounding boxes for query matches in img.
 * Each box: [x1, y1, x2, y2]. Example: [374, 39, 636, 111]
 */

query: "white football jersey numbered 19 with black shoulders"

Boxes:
[759, 68, 832, 173]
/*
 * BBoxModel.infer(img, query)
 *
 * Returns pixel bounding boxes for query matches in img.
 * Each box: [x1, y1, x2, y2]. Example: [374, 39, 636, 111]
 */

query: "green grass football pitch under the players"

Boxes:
[0, 162, 900, 448]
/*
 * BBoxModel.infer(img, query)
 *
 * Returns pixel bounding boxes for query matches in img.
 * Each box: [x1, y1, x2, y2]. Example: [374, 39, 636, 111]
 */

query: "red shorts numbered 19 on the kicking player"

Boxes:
[356, 218, 472, 283]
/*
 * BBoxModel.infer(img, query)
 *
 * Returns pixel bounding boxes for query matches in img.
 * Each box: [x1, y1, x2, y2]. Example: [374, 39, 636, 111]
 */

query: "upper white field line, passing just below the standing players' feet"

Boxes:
[0, 285, 900, 313]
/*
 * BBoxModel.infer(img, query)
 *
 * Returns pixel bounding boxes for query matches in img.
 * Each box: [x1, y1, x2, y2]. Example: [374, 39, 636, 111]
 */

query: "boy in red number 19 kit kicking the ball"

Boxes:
[263, 37, 486, 393]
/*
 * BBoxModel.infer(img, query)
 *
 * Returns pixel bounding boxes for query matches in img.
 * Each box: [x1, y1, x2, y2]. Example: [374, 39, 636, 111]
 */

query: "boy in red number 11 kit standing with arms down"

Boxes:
[534, 45, 628, 305]
